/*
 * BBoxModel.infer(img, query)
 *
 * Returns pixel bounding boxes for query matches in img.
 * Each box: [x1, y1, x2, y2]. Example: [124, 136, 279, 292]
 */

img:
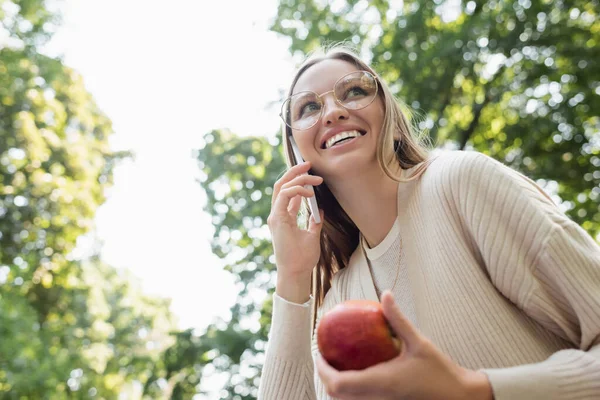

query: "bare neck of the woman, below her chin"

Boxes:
[327, 162, 400, 248]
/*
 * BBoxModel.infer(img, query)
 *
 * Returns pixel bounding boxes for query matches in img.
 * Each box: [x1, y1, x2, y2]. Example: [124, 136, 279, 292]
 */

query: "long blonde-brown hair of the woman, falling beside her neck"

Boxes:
[283, 44, 428, 328]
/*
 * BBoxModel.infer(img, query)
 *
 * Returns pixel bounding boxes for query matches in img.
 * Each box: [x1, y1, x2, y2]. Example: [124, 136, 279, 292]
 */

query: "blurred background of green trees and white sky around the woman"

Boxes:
[0, 0, 600, 400]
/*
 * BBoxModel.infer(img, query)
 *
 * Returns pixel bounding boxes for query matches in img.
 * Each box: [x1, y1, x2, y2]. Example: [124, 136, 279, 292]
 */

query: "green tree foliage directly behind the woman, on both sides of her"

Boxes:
[193, 0, 600, 400]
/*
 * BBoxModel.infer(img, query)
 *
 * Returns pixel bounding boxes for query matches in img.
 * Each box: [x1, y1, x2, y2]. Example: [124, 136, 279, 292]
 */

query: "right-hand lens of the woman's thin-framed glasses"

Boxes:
[333, 71, 377, 110]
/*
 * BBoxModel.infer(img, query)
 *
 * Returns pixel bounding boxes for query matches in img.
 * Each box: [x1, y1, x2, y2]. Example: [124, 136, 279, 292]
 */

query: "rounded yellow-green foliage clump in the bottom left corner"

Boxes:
[0, 260, 177, 399]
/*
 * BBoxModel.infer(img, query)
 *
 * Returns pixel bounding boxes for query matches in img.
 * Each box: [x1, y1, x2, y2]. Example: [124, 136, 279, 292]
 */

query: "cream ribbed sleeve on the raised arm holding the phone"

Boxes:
[258, 282, 339, 400]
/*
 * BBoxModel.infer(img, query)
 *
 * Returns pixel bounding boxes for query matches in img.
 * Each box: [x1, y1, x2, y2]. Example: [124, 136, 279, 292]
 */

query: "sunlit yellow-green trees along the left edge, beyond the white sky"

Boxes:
[0, 0, 182, 399]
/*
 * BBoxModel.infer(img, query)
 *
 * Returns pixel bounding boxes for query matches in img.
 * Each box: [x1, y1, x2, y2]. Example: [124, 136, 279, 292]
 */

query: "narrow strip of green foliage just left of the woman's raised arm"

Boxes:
[192, 131, 285, 400]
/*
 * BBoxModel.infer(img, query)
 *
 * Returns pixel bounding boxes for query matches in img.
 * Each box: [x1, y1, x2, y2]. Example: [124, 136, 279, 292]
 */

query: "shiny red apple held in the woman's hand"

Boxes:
[317, 300, 402, 371]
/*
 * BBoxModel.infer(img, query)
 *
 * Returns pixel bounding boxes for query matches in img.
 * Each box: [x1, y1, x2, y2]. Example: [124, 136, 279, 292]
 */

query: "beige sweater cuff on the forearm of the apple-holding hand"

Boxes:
[481, 350, 599, 400]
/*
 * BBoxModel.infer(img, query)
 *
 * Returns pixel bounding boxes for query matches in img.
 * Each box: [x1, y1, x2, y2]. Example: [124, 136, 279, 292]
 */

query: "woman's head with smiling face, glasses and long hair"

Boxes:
[281, 45, 427, 320]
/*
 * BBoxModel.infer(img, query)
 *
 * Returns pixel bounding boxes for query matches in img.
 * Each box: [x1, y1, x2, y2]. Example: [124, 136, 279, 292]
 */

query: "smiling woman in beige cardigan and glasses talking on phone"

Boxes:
[259, 45, 600, 400]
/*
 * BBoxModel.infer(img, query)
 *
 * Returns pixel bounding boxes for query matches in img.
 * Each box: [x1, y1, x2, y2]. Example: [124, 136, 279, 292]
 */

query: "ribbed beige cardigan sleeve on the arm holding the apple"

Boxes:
[453, 153, 600, 400]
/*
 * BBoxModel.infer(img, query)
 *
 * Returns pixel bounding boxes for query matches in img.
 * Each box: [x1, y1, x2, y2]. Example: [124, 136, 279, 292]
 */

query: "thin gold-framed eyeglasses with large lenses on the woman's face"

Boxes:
[279, 71, 377, 130]
